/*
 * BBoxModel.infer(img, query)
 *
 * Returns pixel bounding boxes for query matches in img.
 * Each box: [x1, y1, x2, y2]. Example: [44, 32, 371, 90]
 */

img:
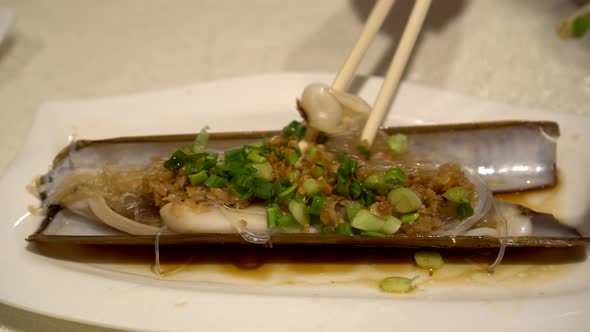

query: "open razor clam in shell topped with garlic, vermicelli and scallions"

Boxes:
[28, 122, 587, 248]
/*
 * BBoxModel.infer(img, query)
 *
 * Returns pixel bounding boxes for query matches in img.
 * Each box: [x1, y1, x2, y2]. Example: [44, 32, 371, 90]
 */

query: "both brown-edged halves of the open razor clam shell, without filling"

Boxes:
[27, 121, 590, 248]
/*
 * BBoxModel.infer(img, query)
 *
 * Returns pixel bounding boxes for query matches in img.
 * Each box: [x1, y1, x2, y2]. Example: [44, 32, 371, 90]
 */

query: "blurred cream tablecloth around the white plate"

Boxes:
[0, 0, 590, 331]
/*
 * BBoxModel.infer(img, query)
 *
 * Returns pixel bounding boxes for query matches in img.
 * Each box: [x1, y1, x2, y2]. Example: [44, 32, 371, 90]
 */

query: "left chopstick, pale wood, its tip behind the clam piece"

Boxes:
[332, 0, 395, 91]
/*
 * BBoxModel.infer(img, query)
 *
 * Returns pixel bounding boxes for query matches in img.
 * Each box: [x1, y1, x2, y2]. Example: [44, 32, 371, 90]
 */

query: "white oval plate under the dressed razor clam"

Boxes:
[0, 73, 590, 332]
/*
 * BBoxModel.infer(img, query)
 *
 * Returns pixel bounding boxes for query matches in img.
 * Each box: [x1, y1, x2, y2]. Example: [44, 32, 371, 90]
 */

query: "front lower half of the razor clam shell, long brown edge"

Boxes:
[26, 202, 590, 249]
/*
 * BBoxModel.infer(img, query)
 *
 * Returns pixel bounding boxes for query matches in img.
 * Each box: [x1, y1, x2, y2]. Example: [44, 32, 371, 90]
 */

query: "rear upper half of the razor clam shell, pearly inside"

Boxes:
[46, 121, 559, 193]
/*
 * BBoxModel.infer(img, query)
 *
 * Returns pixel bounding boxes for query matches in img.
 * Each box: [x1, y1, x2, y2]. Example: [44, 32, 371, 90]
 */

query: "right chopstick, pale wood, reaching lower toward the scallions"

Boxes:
[361, 0, 432, 147]
